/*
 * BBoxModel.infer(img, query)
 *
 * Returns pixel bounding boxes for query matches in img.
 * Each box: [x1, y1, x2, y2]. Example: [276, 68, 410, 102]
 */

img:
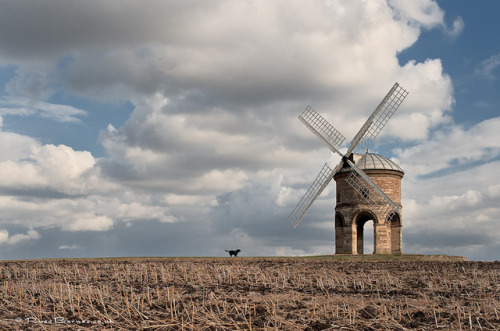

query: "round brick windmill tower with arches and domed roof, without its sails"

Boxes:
[334, 153, 404, 254]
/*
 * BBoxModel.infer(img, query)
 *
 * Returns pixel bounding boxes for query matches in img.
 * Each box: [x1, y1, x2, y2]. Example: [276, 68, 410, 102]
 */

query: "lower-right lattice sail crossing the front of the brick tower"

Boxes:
[346, 160, 399, 223]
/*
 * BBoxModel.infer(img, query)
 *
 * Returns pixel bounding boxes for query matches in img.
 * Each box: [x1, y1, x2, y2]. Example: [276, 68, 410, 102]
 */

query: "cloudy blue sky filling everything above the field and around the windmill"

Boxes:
[0, 0, 500, 260]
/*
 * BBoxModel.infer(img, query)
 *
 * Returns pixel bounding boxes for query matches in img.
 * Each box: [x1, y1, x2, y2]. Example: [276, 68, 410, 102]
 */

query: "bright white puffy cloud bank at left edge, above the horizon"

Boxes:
[0, 124, 178, 233]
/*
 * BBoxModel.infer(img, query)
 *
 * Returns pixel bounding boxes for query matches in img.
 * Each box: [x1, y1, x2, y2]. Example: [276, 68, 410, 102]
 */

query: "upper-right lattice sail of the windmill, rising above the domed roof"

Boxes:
[346, 83, 408, 156]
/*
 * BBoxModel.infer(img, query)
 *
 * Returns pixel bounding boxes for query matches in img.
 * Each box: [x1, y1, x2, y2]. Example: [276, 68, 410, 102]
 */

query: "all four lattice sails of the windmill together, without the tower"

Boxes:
[288, 83, 408, 228]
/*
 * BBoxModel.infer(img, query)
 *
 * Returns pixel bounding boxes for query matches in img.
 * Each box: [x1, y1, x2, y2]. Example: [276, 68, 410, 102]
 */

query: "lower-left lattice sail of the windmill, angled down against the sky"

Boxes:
[288, 163, 334, 228]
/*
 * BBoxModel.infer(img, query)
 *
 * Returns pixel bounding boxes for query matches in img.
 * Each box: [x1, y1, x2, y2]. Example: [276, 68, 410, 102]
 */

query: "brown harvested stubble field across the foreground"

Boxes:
[0, 257, 500, 330]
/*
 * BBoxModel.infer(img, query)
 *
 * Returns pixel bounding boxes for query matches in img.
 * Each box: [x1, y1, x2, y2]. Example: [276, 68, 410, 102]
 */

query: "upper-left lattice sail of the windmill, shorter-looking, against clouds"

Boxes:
[299, 106, 345, 156]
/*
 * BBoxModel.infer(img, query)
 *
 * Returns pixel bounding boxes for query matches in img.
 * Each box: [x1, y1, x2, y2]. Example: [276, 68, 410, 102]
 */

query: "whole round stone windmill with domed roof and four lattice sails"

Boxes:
[288, 83, 408, 254]
